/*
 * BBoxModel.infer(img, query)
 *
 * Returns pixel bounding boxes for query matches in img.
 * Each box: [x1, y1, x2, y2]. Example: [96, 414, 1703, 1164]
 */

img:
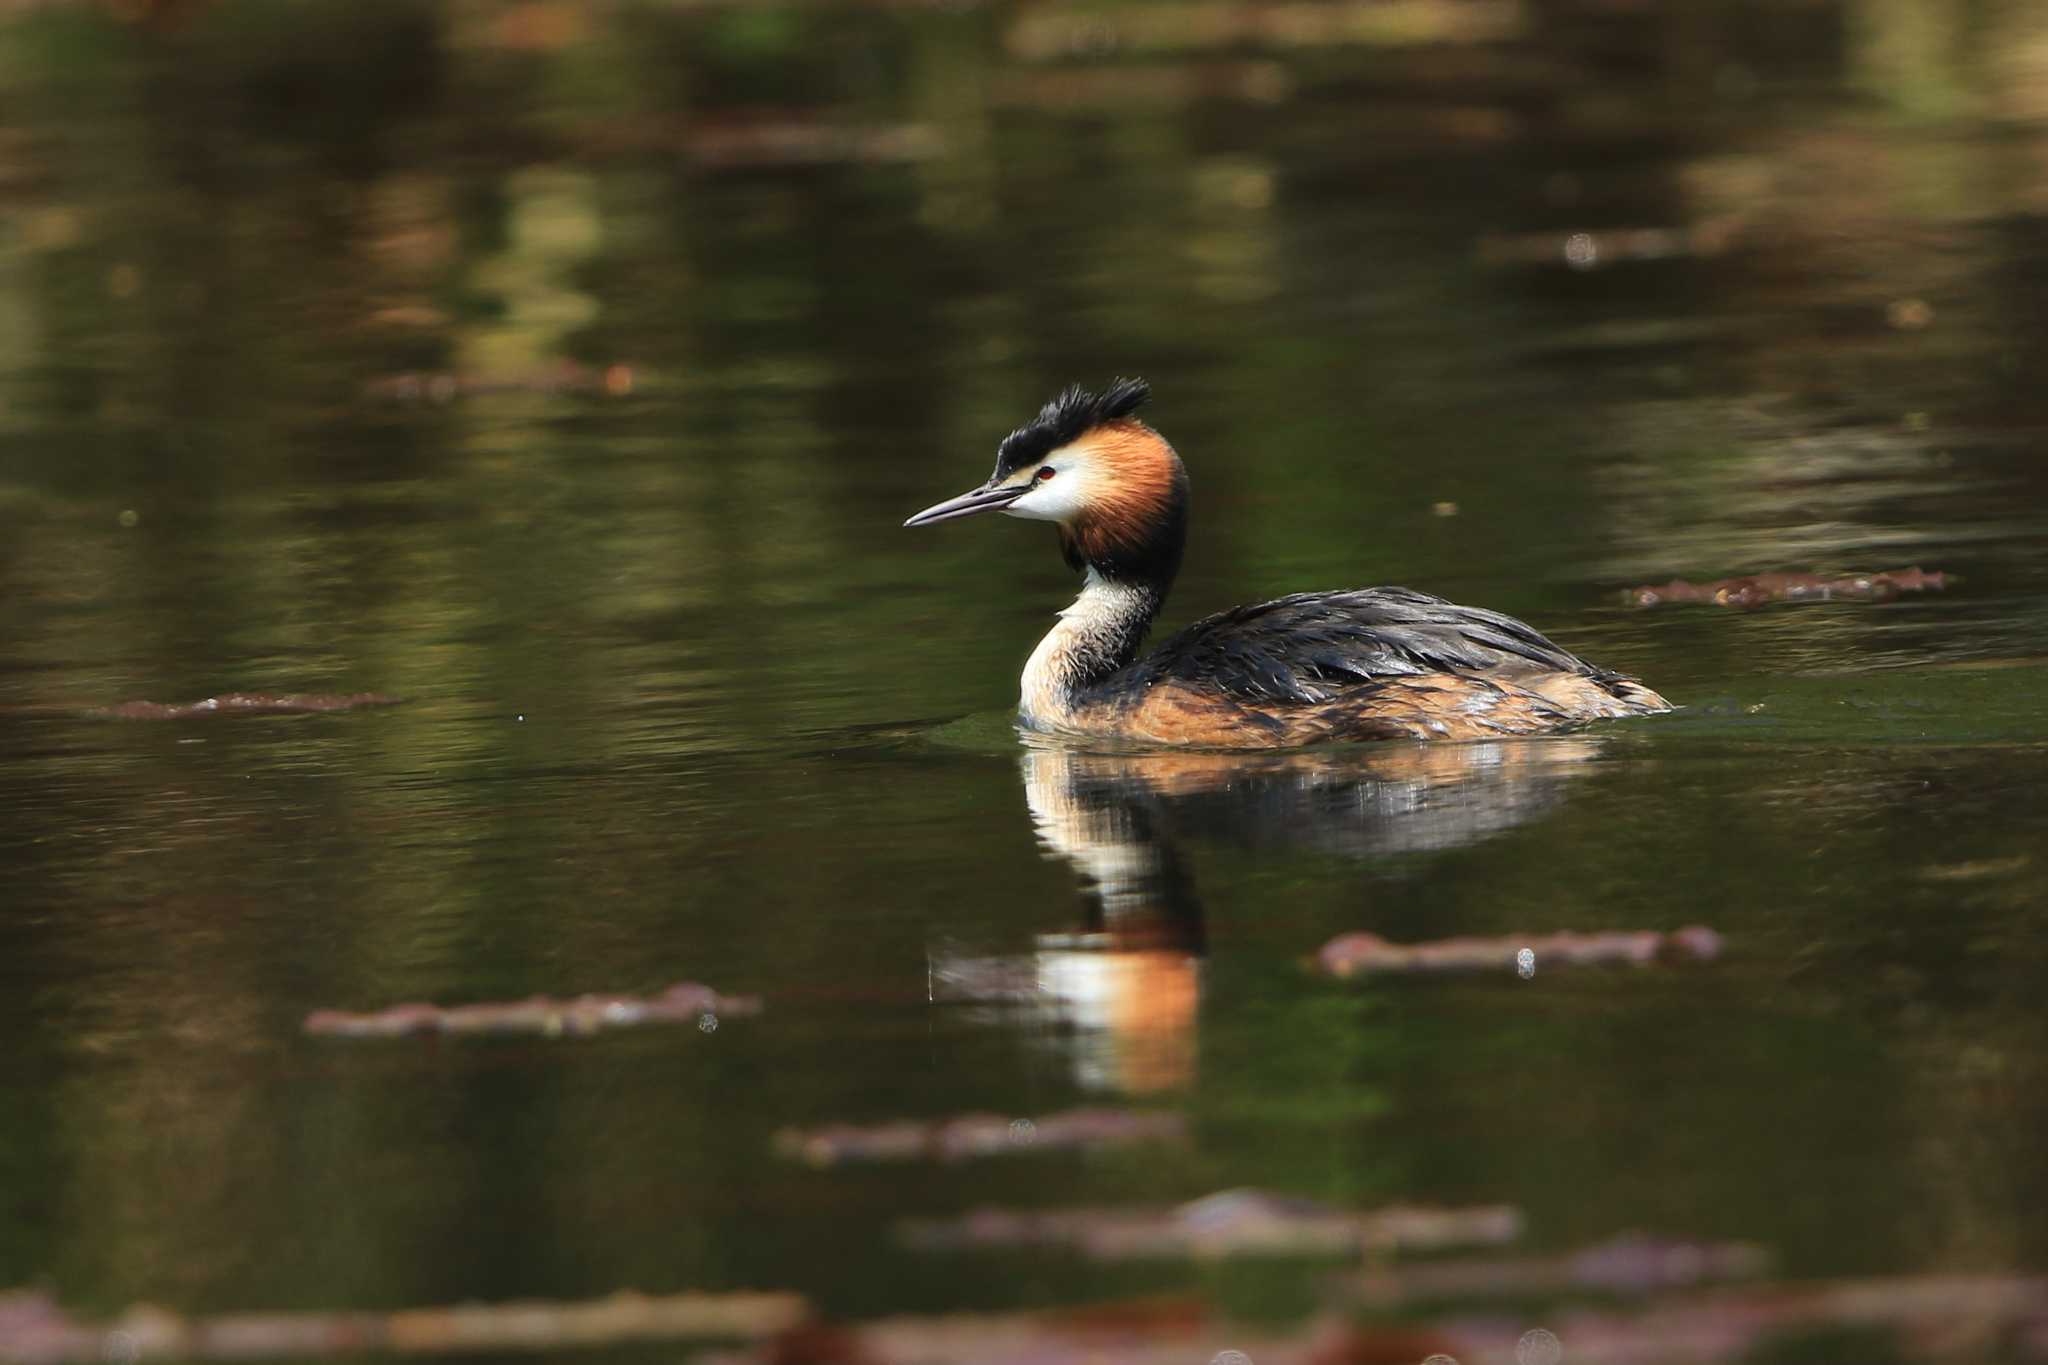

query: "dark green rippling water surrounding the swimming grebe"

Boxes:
[0, 0, 2048, 1350]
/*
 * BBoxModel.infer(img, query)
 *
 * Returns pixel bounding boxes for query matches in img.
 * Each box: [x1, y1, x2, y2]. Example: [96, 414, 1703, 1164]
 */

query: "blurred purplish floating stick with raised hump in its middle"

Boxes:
[897, 1189, 1522, 1261]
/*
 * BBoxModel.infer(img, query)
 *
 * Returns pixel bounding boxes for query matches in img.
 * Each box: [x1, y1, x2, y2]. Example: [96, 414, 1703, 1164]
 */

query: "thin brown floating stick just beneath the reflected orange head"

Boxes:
[774, 1109, 1188, 1166]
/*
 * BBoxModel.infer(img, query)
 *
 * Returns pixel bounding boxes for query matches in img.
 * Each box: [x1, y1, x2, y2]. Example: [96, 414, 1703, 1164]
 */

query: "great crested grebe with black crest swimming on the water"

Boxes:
[903, 379, 1671, 749]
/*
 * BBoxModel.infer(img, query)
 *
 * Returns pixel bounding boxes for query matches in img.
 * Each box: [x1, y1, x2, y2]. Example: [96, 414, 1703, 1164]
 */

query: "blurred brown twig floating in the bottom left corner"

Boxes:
[0, 1289, 809, 1365]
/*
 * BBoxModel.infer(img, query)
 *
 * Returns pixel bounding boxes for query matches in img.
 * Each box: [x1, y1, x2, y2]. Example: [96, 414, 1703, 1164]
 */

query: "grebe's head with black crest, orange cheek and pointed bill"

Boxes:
[903, 379, 1188, 581]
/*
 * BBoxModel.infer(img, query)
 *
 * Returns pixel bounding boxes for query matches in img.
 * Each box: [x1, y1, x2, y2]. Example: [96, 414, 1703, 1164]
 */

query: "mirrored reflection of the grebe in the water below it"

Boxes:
[934, 737, 1599, 1093]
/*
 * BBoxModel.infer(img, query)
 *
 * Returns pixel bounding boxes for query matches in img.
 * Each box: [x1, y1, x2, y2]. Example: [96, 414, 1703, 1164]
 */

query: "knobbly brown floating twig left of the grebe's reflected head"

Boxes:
[305, 980, 762, 1038]
